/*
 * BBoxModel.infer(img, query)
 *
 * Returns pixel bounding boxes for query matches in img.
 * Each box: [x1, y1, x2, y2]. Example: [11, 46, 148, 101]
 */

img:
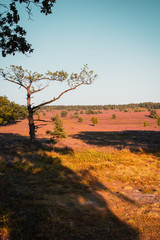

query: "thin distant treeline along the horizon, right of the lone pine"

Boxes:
[41, 102, 160, 111]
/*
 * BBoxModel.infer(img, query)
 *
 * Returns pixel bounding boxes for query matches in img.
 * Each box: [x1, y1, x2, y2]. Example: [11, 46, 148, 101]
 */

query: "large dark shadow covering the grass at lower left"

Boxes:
[0, 134, 139, 240]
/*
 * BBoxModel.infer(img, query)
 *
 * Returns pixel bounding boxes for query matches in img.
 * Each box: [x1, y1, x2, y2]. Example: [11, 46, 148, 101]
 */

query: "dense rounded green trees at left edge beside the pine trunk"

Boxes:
[0, 96, 27, 125]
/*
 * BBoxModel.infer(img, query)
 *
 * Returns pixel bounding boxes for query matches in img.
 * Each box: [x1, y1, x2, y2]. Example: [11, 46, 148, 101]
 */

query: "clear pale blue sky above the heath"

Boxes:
[0, 0, 160, 105]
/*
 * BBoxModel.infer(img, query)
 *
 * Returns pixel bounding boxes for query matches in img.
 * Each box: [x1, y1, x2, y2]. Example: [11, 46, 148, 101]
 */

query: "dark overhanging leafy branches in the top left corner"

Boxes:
[0, 0, 56, 57]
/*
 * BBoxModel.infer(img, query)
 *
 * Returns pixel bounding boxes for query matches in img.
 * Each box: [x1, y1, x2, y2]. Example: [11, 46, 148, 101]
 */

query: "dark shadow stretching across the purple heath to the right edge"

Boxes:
[72, 130, 160, 155]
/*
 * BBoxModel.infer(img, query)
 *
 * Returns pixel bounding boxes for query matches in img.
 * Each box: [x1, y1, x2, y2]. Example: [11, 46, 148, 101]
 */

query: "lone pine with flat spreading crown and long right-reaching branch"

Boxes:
[0, 65, 97, 142]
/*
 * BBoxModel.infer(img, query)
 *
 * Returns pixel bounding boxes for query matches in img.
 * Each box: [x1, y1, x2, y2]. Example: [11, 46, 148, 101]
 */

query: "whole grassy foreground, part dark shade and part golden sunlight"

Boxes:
[0, 139, 160, 240]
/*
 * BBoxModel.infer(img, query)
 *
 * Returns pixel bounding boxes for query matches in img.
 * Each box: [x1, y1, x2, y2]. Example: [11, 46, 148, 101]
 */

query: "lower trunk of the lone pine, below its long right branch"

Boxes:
[28, 106, 36, 142]
